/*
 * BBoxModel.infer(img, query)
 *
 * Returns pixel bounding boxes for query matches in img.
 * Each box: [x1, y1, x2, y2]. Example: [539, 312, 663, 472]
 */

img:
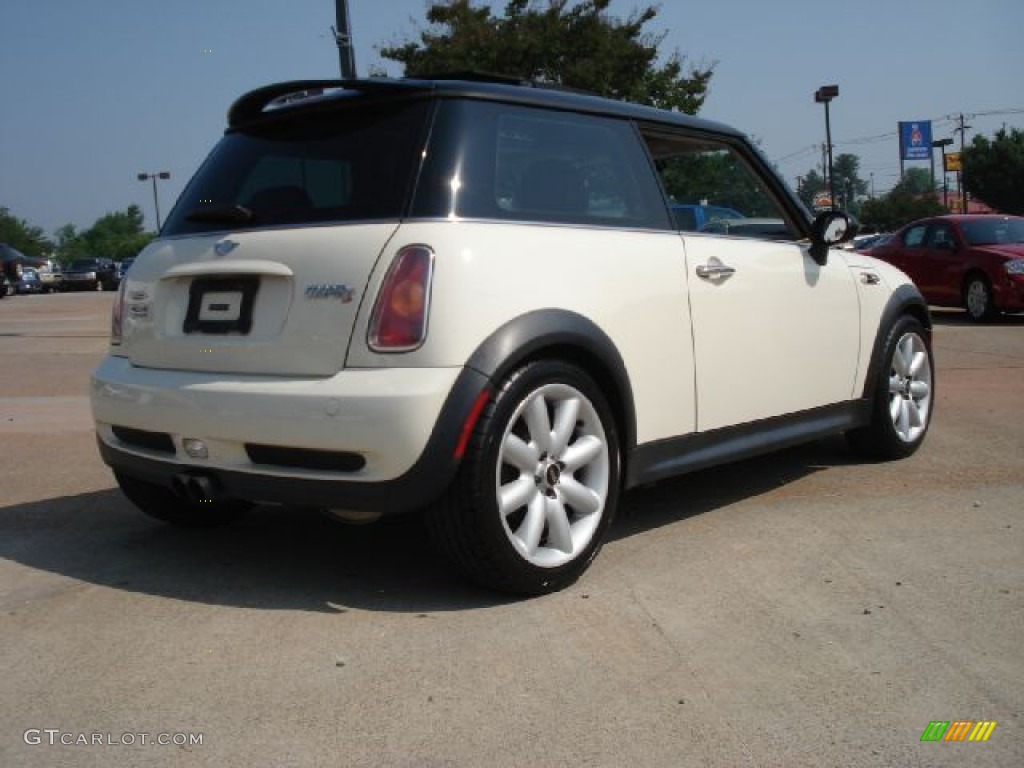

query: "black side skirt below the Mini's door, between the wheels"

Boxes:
[626, 398, 871, 487]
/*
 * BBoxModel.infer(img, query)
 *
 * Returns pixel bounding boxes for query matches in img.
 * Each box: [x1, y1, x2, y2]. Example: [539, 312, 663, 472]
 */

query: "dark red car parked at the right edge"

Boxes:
[871, 215, 1024, 322]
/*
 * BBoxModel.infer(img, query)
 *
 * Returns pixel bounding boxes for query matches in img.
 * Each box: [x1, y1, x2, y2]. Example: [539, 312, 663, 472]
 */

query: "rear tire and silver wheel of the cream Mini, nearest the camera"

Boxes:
[426, 360, 621, 595]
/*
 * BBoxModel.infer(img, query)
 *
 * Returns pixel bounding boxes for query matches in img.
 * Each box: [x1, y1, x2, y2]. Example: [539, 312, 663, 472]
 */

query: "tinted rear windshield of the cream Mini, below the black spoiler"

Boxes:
[162, 100, 430, 234]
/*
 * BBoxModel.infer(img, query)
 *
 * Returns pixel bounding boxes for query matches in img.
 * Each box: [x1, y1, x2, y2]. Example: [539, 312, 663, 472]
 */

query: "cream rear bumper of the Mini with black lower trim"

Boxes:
[91, 356, 486, 513]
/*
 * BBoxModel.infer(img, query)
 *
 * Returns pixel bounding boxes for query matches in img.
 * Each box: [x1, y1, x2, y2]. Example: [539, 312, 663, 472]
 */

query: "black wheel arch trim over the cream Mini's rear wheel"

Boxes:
[466, 309, 636, 462]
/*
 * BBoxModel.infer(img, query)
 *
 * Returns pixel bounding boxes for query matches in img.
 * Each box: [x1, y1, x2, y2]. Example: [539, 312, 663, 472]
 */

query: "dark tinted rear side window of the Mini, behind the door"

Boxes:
[413, 100, 669, 229]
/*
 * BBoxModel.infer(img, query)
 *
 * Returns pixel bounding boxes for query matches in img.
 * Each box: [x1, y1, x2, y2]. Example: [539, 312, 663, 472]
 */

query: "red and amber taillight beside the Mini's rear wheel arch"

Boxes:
[367, 246, 434, 352]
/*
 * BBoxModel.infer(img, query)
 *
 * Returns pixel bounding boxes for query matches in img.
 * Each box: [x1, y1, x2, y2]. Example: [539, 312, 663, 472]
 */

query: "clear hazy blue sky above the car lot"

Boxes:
[0, 0, 1024, 236]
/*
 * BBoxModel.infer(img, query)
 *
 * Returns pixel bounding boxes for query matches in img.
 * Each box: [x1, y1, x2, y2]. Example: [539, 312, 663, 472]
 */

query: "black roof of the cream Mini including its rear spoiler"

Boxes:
[227, 74, 743, 137]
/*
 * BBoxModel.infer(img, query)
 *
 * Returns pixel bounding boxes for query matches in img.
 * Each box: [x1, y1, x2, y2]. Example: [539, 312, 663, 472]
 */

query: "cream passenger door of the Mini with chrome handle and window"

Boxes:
[648, 131, 860, 432]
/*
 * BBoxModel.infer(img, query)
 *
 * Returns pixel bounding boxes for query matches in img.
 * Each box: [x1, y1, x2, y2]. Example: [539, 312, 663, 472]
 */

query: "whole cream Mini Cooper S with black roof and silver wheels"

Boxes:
[91, 79, 935, 594]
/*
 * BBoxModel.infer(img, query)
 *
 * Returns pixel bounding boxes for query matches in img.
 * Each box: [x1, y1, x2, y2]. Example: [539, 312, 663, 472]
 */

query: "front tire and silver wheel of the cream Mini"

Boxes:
[846, 315, 935, 460]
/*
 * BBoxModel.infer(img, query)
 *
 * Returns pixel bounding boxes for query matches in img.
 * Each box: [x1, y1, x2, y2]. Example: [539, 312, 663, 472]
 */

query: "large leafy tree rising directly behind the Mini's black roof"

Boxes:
[381, 0, 714, 115]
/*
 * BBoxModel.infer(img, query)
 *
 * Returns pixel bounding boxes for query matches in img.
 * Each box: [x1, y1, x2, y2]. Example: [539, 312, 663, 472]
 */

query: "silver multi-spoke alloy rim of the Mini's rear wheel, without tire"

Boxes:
[496, 384, 610, 568]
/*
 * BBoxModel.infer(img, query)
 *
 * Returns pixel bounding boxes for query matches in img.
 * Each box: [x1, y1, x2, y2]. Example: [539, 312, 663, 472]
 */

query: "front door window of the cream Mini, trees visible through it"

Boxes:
[644, 131, 795, 240]
